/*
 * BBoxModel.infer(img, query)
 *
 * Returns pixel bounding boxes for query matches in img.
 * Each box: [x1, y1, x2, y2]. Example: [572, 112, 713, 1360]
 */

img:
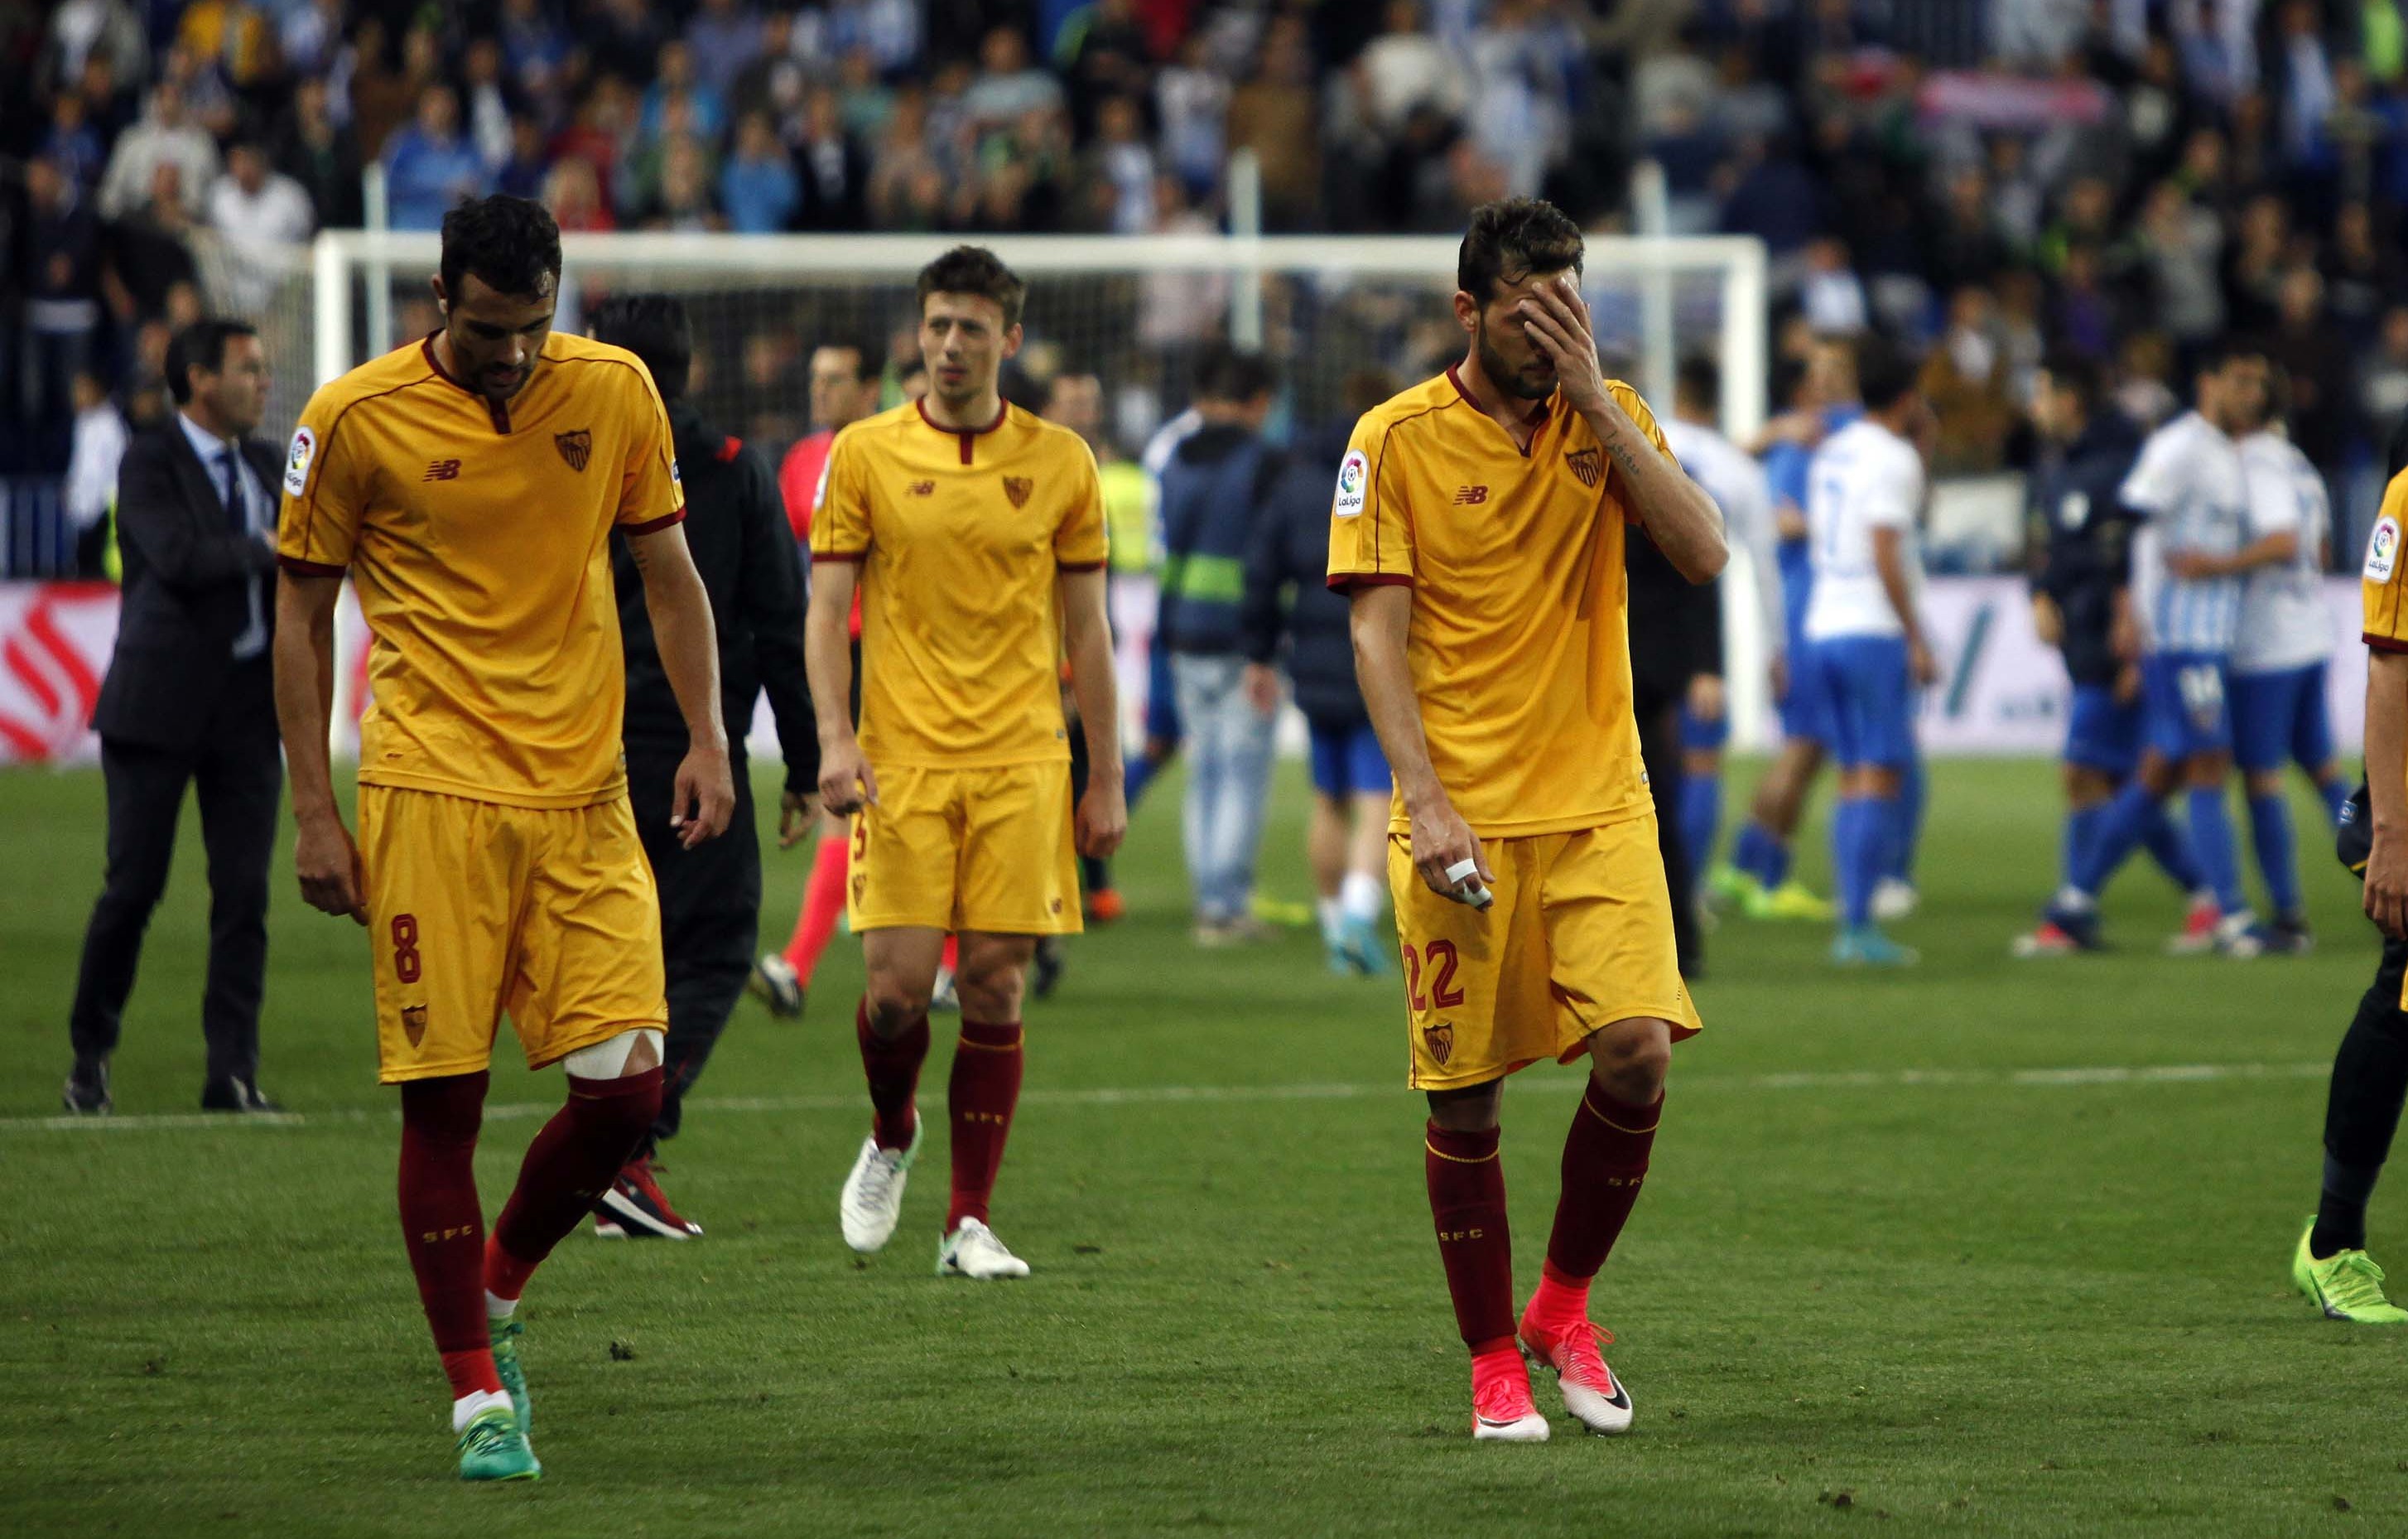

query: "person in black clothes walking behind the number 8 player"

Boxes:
[590, 294, 819, 1240]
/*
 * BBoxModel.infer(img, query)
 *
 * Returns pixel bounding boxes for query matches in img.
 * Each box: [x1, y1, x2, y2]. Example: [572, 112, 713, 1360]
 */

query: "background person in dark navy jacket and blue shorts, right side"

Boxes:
[2015, 356, 2201, 956]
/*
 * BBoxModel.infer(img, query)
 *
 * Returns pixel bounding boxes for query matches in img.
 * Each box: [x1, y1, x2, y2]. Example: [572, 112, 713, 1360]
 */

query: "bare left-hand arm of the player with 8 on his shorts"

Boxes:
[272, 571, 368, 925]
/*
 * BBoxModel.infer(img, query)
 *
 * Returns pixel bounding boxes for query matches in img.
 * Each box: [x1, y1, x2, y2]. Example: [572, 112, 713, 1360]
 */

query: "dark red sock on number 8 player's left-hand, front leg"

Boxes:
[400, 1074, 501, 1399]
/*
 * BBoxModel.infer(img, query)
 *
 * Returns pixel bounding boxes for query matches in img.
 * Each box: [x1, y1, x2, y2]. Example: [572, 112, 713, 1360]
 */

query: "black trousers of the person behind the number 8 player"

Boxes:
[626, 746, 761, 1154]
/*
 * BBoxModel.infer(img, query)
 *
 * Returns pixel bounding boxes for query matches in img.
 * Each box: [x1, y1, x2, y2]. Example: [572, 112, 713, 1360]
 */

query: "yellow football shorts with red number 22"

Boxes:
[1387, 814, 1705, 1091]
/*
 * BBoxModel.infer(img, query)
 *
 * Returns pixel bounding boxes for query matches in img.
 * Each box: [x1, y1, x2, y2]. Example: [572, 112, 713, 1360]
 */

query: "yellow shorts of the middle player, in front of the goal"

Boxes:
[848, 759, 1081, 934]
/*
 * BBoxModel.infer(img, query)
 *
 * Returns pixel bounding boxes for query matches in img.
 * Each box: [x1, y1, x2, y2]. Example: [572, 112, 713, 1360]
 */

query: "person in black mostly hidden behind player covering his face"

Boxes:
[1623, 438, 1722, 978]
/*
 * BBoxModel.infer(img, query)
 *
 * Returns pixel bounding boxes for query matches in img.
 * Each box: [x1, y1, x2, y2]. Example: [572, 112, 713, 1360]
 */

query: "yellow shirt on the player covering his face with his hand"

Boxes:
[1329, 369, 1671, 838]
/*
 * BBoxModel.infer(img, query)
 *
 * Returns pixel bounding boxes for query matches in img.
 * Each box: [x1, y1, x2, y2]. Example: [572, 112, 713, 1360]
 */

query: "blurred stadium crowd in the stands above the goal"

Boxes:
[0, 0, 2408, 523]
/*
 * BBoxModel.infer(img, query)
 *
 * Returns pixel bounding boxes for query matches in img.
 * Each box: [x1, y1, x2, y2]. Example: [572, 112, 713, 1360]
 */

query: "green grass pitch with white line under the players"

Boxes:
[0, 764, 2408, 1539]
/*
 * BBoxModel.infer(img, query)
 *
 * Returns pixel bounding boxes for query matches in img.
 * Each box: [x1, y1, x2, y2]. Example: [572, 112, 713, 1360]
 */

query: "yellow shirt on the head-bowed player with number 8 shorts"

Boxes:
[277, 332, 686, 807]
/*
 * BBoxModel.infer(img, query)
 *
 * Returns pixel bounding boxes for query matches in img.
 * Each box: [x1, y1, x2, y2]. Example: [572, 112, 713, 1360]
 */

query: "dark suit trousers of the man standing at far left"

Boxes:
[67, 658, 284, 1079]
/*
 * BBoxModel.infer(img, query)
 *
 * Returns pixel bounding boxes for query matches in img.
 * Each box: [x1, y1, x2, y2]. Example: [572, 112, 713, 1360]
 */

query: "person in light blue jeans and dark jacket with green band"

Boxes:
[1158, 352, 1283, 947]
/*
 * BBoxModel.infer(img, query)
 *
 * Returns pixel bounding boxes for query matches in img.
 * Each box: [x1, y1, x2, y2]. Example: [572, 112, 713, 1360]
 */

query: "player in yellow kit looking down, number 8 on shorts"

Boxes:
[275, 197, 734, 1479]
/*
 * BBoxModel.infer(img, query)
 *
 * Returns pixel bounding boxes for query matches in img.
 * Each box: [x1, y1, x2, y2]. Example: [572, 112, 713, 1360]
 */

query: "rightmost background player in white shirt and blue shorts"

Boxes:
[2232, 383, 2350, 952]
